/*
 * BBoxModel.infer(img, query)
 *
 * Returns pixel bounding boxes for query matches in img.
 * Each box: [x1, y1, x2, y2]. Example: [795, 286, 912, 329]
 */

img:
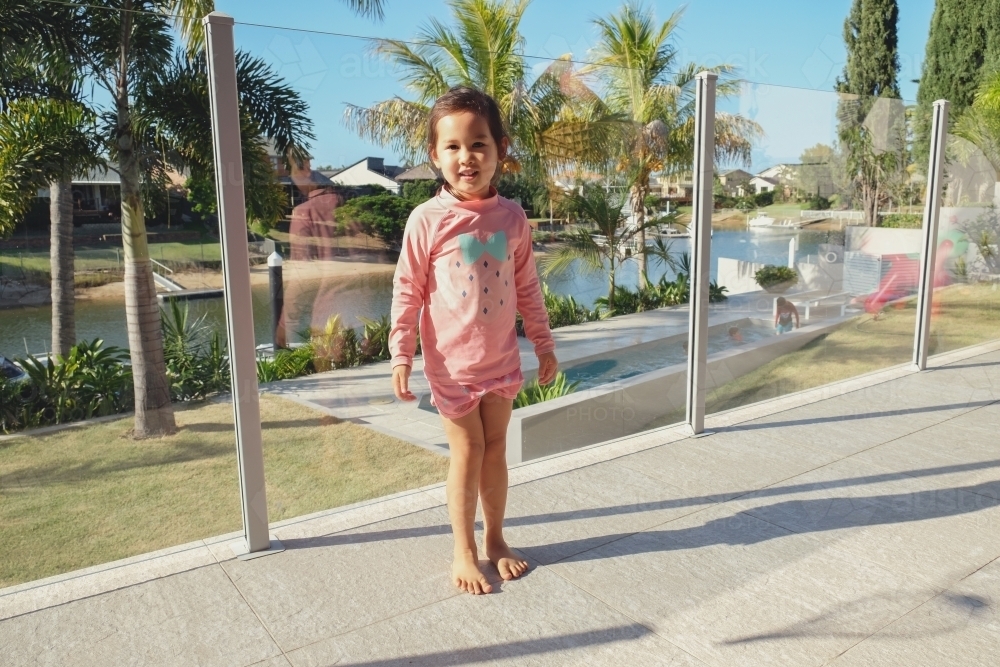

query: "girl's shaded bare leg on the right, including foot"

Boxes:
[479, 392, 528, 579]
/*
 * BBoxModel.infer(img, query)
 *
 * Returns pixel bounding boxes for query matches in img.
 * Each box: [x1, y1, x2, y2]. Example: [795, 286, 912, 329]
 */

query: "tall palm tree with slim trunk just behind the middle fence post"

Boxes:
[582, 1, 762, 286]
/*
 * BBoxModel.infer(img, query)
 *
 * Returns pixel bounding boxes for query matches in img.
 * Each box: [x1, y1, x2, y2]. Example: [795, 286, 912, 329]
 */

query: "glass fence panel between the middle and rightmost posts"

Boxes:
[707, 84, 923, 413]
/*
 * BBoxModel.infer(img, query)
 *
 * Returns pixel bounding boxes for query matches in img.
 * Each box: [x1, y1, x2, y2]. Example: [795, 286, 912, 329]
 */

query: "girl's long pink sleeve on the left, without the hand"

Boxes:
[389, 211, 430, 368]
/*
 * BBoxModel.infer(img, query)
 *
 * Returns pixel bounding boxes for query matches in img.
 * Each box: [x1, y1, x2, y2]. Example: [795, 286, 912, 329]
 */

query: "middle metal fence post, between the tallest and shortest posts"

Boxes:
[687, 72, 719, 435]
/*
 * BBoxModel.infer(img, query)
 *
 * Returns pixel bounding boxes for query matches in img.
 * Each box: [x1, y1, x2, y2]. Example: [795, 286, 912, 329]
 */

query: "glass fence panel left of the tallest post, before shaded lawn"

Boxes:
[0, 6, 241, 587]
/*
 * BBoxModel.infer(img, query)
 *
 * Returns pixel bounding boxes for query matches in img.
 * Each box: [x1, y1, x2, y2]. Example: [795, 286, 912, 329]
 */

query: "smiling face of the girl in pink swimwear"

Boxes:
[431, 111, 507, 200]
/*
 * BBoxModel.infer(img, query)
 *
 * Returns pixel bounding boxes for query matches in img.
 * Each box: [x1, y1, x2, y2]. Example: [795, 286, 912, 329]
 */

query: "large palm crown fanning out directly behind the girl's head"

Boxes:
[344, 0, 615, 188]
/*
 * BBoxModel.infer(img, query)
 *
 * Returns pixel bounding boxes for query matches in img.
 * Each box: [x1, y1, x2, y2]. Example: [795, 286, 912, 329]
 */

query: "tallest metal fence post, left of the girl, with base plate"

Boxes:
[202, 12, 282, 557]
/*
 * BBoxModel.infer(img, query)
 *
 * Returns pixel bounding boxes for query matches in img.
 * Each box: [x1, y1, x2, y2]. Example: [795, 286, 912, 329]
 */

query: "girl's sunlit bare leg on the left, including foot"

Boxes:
[441, 407, 493, 595]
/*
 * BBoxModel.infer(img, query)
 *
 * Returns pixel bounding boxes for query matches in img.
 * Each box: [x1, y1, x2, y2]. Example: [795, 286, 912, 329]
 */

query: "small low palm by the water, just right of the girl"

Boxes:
[541, 185, 677, 311]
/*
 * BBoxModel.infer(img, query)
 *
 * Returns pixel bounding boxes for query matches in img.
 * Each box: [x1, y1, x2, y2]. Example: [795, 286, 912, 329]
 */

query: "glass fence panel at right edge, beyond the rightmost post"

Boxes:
[928, 127, 1000, 354]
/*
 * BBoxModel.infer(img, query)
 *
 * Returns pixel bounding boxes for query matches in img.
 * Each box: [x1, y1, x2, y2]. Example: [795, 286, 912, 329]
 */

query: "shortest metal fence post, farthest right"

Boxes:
[913, 100, 951, 371]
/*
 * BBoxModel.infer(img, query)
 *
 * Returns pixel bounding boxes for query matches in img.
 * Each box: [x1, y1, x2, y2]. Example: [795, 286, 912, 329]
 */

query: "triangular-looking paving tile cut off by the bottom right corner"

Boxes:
[830, 561, 1000, 667]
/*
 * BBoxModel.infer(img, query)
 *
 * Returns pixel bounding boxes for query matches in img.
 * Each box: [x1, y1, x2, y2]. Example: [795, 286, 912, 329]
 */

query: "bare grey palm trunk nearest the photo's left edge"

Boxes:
[49, 177, 76, 356]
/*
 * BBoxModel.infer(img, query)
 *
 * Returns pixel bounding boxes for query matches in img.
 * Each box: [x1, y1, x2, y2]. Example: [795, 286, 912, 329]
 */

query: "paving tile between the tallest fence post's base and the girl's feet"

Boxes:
[223, 507, 457, 651]
